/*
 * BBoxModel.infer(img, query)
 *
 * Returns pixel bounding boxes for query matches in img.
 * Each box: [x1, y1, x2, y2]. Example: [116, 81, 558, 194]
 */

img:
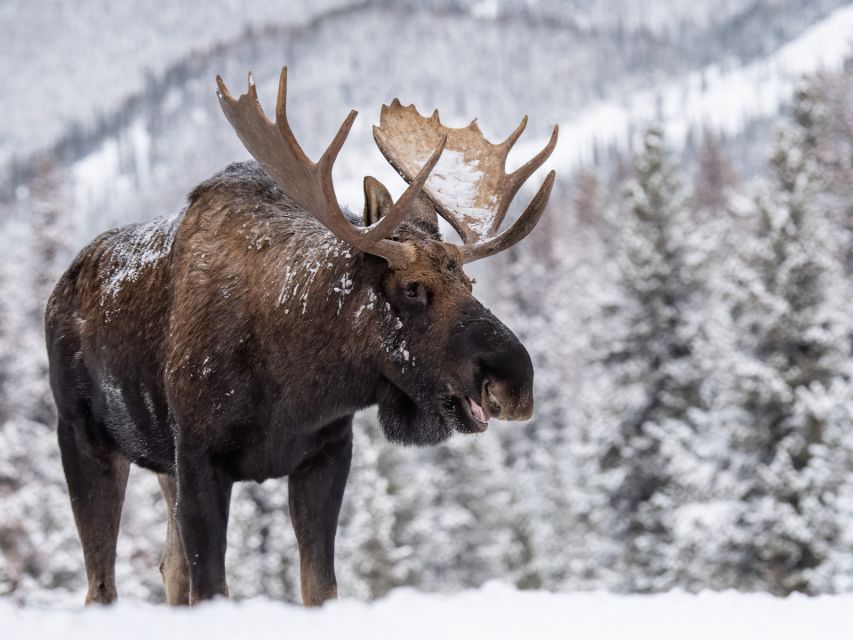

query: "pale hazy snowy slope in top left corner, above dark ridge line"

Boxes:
[0, 0, 354, 166]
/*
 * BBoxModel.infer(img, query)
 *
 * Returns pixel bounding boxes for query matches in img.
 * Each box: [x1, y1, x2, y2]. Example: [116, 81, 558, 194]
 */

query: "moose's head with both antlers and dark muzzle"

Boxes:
[217, 67, 558, 444]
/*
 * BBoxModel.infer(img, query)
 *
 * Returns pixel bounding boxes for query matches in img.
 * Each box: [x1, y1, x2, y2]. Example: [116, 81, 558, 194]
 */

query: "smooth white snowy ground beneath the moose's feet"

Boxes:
[0, 584, 853, 640]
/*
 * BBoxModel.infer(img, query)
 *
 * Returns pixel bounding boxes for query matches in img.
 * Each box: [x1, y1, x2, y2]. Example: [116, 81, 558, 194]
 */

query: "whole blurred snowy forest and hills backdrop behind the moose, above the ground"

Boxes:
[0, 0, 853, 604]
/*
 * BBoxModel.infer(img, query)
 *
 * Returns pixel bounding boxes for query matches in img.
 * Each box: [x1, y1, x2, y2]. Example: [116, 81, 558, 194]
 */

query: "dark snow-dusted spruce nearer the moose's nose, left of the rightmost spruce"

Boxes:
[586, 129, 709, 591]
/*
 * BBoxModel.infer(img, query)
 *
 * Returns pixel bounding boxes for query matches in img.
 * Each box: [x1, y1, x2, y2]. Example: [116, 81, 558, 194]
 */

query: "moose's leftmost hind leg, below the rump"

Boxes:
[57, 419, 130, 605]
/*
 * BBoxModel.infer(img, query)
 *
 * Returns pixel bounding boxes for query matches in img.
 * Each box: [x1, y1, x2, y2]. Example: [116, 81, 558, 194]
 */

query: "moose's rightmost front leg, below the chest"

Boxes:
[288, 416, 352, 607]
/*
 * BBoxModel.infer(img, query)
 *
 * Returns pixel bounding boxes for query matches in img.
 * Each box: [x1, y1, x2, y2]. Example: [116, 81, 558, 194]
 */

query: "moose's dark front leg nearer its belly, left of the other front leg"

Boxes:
[175, 446, 233, 605]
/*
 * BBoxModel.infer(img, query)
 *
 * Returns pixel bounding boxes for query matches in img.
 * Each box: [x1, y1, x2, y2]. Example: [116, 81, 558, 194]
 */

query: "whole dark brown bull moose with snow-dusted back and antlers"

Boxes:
[45, 68, 557, 605]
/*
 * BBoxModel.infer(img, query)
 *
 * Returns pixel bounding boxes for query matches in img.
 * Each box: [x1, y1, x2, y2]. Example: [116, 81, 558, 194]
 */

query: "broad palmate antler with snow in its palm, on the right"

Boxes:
[373, 98, 559, 262]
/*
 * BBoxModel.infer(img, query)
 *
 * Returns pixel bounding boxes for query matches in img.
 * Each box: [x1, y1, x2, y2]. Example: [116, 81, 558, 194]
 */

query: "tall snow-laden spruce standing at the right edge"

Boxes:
[712, 92, 851, 594]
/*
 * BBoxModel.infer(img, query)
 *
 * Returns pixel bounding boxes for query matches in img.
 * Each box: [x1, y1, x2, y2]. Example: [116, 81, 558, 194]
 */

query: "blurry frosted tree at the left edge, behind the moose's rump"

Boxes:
[0, 160, 84, 598]
